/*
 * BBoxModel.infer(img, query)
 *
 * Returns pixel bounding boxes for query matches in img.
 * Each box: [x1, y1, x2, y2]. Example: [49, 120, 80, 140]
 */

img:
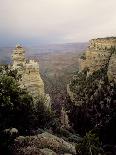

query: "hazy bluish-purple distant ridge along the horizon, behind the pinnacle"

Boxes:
[0, 43, 88, 64]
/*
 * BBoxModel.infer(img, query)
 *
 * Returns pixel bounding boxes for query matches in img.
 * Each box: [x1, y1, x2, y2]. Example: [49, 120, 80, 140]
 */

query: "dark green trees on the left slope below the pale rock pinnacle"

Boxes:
[0, 66, 58, 153]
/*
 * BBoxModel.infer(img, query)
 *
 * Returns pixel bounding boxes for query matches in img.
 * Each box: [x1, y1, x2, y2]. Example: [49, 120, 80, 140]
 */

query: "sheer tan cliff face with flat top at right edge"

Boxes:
[80, 38, 116, 79]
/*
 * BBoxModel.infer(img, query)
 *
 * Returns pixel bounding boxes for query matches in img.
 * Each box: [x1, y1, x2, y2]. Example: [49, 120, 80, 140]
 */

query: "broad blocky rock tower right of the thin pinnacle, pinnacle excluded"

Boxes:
[20, 60, 45, 96]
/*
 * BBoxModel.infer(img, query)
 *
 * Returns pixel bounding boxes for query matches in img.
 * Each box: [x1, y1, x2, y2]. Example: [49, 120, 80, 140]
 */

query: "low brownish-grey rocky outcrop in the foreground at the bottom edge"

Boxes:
[13, 132, 76, 155]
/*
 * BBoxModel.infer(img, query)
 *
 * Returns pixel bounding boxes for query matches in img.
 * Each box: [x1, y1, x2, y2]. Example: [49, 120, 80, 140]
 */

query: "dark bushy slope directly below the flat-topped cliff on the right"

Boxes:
[69, 66, 116, 144]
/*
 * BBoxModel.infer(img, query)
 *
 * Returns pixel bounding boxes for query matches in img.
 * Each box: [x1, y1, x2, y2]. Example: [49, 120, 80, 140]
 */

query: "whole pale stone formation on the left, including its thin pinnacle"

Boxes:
[11, 45, 51, 107]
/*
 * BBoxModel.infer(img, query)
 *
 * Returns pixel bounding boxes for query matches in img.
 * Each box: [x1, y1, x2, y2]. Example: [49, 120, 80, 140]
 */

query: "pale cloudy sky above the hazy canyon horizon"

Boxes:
[0, 0, 116, 46]
